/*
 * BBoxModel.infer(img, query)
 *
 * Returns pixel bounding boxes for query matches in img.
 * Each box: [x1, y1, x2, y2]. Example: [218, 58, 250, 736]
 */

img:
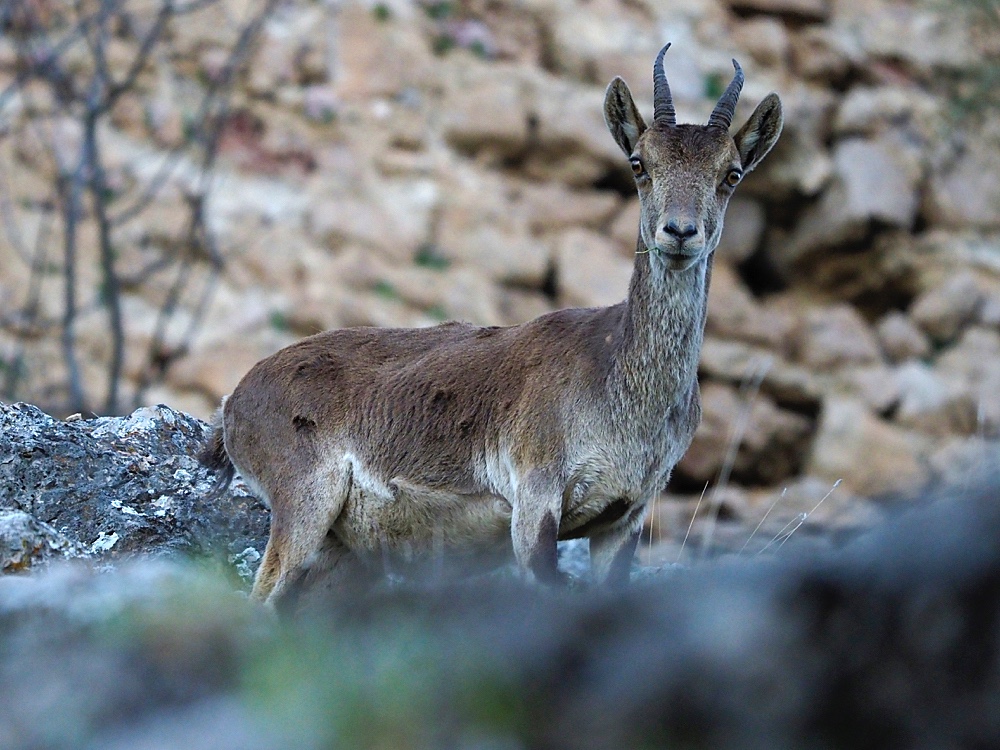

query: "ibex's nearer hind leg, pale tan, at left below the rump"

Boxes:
[250, 475, 348, 606]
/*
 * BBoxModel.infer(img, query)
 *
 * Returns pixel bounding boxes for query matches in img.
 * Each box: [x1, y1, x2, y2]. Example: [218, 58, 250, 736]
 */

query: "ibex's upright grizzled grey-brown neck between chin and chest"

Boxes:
[609, 245, 712, 426]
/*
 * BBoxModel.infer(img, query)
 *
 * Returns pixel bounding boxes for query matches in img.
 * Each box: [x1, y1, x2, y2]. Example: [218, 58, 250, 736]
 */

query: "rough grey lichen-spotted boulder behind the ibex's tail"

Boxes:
[0, 403, 268, 577]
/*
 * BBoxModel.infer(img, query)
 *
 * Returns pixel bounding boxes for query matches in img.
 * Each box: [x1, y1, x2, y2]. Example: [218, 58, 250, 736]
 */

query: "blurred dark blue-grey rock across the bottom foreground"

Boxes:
[0, 479, 1000, 750]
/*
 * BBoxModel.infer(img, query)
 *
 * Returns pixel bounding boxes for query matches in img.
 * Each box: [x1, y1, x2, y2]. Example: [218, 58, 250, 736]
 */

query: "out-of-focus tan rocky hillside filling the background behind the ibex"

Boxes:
[0, 0, 1000, 548]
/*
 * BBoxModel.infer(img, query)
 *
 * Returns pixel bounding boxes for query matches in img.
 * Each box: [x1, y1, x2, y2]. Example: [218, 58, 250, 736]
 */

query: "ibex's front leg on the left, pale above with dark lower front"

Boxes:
[511, 470, 566, 584]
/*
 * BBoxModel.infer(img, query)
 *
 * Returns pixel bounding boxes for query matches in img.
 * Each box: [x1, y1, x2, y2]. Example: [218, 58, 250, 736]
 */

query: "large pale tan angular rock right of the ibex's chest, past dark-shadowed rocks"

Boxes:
[806, 396, 930, 497]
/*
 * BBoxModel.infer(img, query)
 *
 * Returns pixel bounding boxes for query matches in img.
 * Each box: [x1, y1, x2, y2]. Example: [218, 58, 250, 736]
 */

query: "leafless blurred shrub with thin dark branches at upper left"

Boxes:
[0, 0, 278, 412]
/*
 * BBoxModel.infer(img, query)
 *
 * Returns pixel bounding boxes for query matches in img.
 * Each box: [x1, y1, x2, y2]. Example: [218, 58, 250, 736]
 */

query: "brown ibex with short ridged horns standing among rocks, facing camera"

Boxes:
[203, 45, 782, 603]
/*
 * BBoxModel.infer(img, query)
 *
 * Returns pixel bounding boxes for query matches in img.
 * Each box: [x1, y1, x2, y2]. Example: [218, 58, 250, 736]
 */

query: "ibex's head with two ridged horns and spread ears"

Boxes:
[604, 44, 782, 271]
